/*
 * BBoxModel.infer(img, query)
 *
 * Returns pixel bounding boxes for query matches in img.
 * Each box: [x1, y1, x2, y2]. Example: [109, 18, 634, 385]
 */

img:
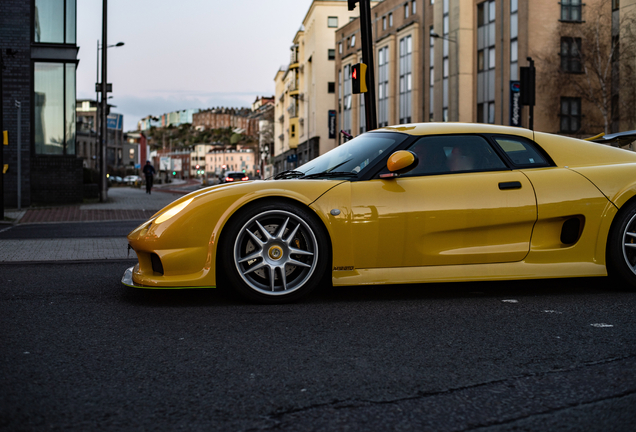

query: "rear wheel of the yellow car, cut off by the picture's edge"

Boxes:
[606, 202, 636, 289]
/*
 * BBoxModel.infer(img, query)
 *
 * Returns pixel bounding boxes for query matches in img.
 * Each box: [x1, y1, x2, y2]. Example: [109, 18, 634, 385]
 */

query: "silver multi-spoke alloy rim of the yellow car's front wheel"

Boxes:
[233, 210, 319, 296]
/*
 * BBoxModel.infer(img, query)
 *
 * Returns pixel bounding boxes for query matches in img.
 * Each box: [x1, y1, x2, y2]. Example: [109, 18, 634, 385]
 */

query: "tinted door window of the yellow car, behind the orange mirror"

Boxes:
[405, 135, 507, 176]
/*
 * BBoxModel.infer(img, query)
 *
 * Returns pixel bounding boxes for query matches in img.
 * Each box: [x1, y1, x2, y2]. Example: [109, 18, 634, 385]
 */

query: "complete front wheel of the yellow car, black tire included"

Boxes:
[219, 201, 331, 304]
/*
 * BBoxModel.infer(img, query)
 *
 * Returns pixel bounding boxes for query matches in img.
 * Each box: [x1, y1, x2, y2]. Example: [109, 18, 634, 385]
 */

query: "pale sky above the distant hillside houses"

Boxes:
[77, 0, 311, 131]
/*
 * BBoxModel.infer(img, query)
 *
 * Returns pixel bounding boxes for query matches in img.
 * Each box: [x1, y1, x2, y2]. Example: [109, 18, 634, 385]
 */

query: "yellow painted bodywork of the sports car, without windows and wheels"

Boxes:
[128, 123, 636, 288]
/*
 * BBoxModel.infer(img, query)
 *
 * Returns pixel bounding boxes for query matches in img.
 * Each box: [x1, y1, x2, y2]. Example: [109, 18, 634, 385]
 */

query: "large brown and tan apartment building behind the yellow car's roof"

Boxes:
[334, 0, 636, 142]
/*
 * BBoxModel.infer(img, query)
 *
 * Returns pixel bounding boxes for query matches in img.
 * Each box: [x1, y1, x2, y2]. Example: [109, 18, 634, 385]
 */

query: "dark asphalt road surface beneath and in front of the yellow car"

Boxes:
[0, 261, 636, 431]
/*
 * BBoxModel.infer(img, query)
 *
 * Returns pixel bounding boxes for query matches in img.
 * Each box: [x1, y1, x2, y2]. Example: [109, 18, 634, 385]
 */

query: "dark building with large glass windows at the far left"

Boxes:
[0, 0, 83, 207]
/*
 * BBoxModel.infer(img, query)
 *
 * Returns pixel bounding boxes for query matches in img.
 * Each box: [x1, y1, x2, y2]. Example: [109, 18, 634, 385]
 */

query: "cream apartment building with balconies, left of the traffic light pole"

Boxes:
[273, 0, 377, 172]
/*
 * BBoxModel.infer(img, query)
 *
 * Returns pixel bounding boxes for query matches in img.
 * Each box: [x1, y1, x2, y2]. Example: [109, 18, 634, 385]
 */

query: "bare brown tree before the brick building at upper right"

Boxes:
[541, 0, 636, 135]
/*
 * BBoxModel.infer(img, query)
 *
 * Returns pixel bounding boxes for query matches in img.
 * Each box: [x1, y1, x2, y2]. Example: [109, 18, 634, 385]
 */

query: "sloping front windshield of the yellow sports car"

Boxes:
[286, 132, 409, 178]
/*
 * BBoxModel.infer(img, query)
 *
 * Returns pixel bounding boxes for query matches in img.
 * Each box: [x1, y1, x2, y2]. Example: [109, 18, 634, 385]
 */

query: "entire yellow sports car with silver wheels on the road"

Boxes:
[122, 123, 636, 303]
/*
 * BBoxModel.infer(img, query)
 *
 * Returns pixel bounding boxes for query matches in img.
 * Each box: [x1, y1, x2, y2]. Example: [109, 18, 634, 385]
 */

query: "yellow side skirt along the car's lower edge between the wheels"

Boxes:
[332, 261, 607, 286]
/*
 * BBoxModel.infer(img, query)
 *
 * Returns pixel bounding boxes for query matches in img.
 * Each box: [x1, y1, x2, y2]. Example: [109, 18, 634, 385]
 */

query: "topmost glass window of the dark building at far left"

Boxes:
[33, 0, 77, 44]
